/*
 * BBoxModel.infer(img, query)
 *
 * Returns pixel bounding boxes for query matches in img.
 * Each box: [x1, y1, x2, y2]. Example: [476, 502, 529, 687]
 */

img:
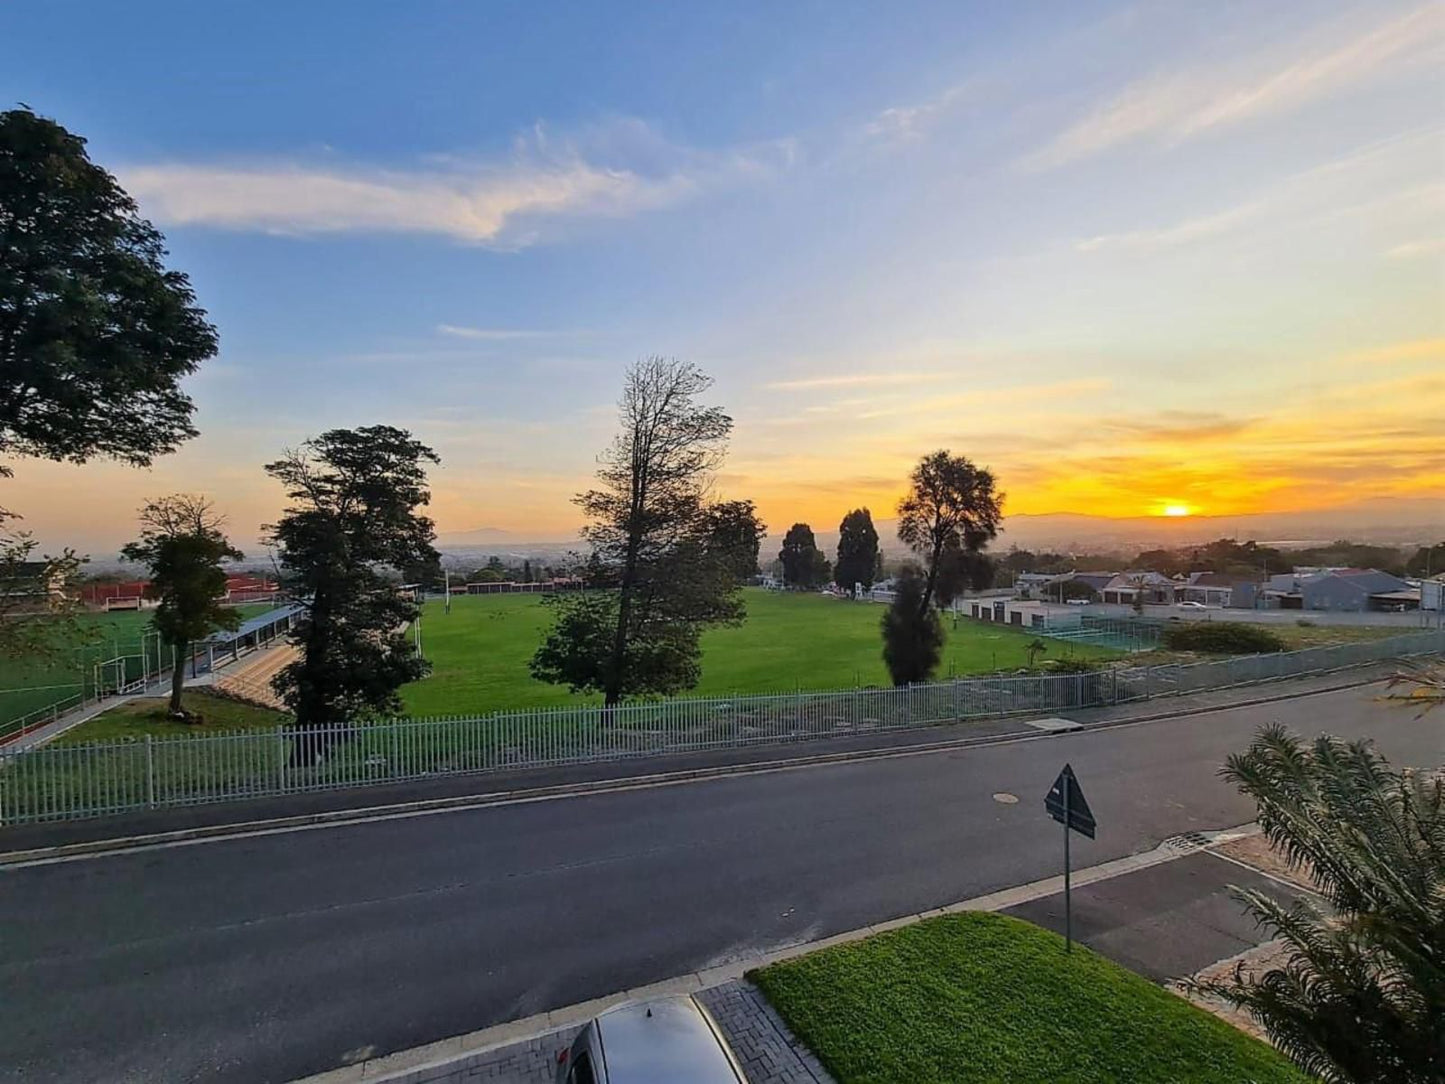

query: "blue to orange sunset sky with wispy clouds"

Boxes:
[0, 0, 1445, 551]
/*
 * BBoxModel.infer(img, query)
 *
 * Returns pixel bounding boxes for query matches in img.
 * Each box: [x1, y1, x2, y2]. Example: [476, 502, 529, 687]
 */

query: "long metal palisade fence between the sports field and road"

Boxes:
[0, 632, 1445, 824]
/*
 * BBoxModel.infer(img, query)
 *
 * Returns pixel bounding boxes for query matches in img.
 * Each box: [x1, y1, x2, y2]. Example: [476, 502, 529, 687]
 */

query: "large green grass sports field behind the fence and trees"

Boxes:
[402, 588, 1120, 715]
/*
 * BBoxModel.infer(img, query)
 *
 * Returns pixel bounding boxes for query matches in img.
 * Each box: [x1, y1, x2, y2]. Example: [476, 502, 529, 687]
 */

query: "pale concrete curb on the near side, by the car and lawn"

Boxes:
[293, 824, 1259, 1084]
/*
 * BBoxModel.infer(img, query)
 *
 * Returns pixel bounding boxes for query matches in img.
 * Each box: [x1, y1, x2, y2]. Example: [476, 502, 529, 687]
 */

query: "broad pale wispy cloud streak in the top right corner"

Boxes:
[1020, 3, 1445, 169]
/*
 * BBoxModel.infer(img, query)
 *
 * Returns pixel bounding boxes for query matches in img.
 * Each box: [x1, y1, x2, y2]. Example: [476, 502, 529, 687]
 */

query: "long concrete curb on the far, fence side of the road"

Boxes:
[0, 676, 1386, 869]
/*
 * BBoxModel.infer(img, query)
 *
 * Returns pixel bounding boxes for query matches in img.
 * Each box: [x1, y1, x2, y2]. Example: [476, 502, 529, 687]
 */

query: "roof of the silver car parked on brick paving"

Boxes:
[597, 997, 738, 1084]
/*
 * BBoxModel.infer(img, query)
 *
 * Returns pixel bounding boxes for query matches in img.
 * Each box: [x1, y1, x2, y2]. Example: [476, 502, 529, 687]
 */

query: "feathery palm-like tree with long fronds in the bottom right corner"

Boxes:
[1192, 726, 1445, 1084]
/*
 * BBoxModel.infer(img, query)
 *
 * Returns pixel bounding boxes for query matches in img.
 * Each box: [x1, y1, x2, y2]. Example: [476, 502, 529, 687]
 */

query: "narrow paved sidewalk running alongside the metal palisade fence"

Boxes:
[0, 663, 1394, 860]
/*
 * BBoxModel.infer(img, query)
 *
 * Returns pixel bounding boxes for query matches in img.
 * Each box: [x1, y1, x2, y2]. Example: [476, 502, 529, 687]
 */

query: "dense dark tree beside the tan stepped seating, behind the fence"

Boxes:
[266, 425, 438, 763]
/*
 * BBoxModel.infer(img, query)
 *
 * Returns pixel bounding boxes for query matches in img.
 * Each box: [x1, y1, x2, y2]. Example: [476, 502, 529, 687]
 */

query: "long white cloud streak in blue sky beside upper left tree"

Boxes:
[120, 120, 792, 249]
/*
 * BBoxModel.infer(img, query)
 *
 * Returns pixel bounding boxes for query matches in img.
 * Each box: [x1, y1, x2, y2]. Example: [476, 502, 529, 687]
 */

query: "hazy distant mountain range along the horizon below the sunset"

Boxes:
[438, 496, 1445, 561]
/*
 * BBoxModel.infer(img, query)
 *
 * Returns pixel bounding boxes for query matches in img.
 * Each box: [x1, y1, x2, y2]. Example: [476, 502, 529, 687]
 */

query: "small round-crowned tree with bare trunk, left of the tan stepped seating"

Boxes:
[120, 493, 244, 720]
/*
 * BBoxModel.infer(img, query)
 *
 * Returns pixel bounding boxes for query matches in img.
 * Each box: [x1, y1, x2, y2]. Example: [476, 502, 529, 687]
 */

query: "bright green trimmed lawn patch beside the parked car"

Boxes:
[751, 912, 1309, 1084]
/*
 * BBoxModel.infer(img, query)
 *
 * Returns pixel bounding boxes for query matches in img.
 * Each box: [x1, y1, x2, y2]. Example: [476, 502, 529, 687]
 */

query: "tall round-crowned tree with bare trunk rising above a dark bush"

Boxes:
[899, 451, 1003, 611]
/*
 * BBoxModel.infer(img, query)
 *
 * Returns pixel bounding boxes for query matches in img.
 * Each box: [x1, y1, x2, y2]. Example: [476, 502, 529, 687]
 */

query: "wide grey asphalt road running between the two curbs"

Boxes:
[0, 688, 1445, 1081]
